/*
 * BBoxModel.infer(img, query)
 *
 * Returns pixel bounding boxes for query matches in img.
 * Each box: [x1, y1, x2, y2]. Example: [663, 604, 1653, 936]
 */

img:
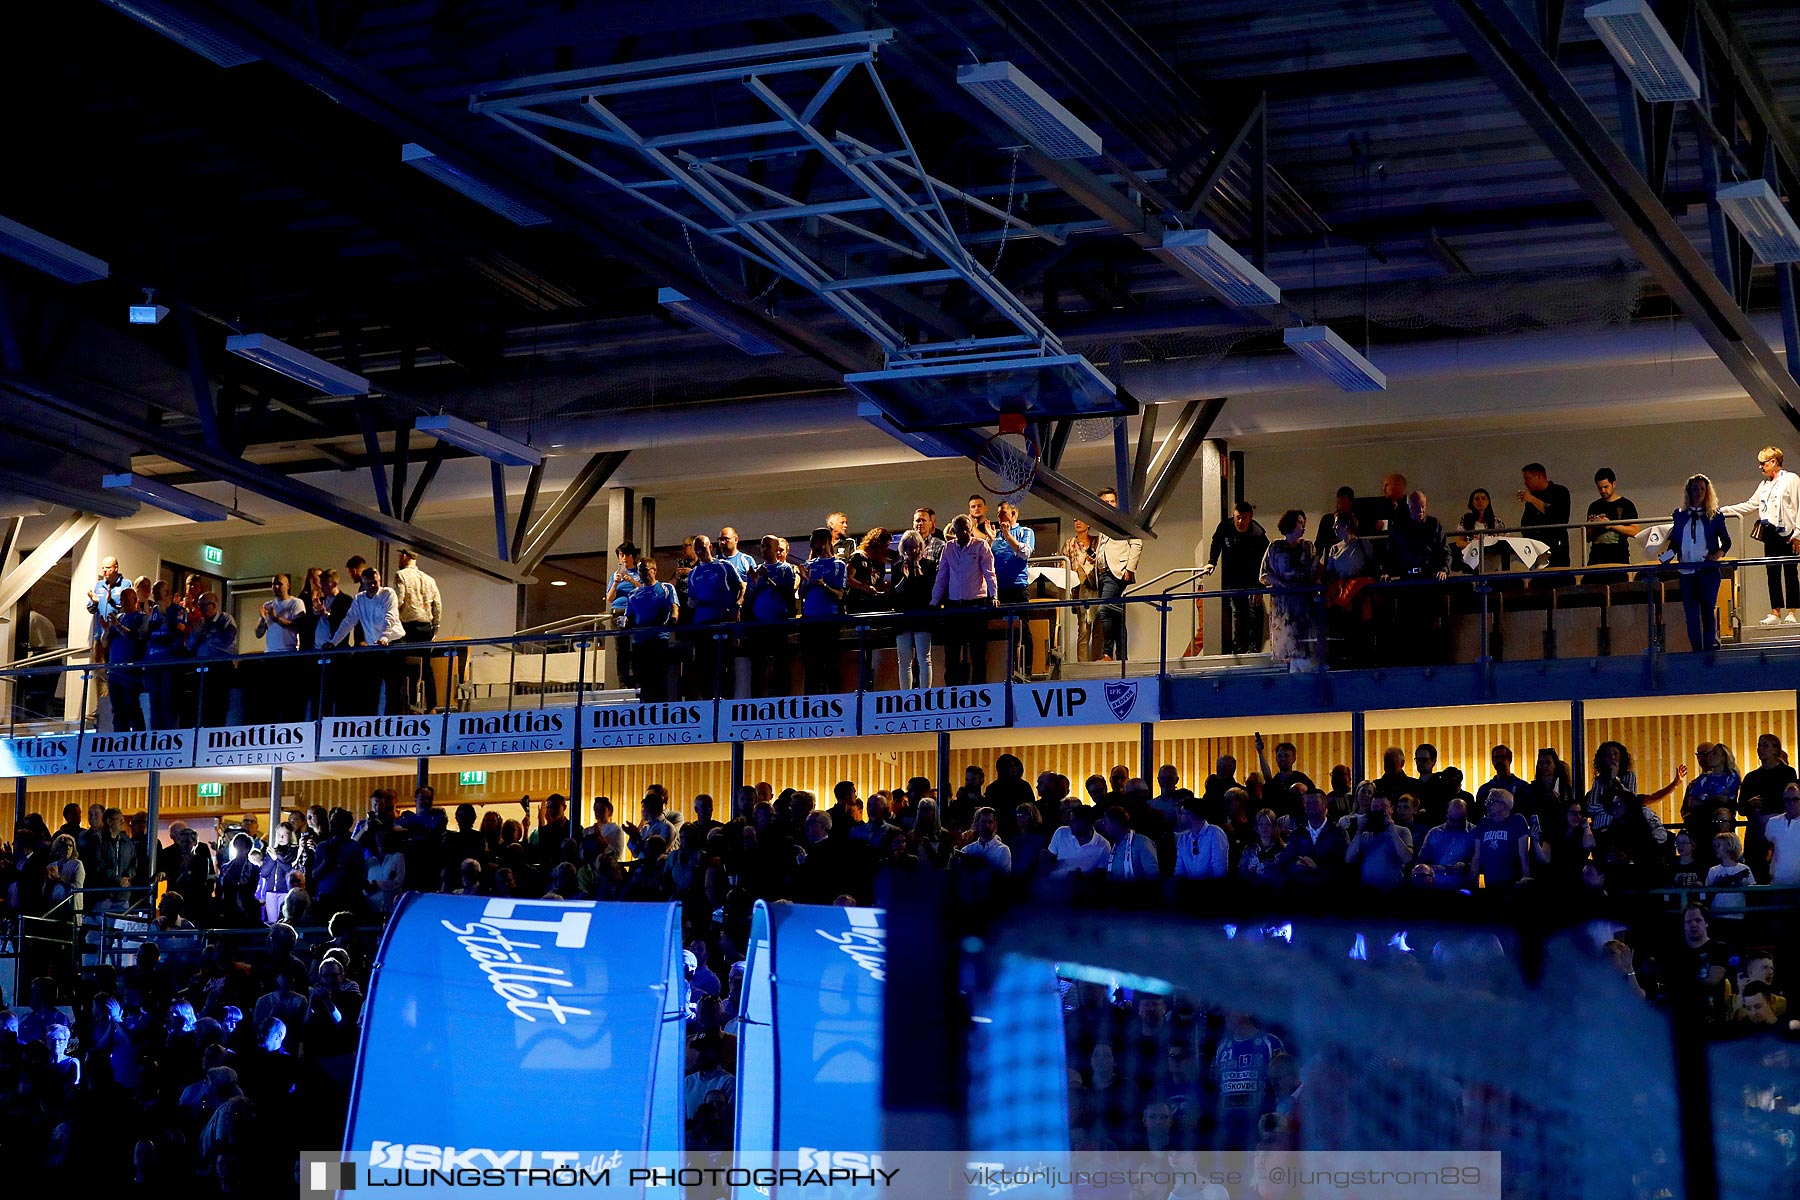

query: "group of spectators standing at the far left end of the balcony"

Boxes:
[88, 549, 443, 732]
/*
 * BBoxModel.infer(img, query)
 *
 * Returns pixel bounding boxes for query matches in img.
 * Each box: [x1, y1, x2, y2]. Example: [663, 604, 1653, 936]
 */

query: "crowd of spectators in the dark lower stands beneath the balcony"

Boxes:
[0, 726, 1800, 1191]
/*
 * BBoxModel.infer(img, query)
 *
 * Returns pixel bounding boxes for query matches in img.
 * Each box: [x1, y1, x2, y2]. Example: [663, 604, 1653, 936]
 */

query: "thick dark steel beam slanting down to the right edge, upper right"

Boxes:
[1433, 0, 1800, 428]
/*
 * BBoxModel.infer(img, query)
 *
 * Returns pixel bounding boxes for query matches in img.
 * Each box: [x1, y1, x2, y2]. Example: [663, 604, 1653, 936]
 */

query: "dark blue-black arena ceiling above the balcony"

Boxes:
[0, 0, 1800, 574]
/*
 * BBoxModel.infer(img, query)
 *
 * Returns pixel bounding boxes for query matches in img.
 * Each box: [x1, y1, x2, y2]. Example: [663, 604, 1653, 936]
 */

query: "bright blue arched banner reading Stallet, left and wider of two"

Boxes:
[346, 892, 688, 1196]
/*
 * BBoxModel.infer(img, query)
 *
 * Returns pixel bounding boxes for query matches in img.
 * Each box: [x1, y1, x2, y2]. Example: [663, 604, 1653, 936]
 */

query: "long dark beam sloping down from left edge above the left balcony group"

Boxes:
[0, 378, 520, 583]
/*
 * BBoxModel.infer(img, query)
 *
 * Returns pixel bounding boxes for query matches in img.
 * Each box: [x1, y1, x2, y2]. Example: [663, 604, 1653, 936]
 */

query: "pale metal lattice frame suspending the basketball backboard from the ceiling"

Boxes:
[470, 29, 1060, 363]
